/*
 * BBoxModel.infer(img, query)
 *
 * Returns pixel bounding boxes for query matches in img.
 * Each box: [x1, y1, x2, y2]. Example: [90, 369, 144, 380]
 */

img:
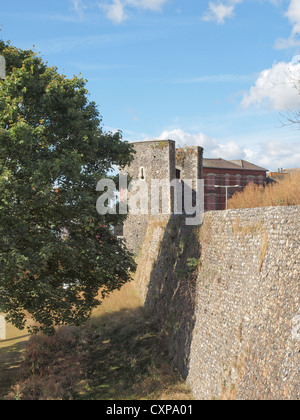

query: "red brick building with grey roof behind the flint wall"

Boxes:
[203, 159, 267, 211]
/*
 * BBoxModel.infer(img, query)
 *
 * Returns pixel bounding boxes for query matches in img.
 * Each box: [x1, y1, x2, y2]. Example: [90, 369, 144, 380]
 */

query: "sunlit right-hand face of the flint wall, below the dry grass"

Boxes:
[188, 207, 300, 400]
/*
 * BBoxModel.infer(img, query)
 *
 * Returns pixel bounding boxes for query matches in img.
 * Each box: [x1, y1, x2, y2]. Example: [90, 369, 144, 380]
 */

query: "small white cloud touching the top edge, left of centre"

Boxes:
[99, 0, 168, 23]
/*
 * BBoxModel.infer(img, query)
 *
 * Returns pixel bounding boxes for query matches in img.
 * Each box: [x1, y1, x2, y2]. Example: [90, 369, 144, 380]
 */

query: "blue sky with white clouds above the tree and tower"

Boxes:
[0, 0, 300, 170]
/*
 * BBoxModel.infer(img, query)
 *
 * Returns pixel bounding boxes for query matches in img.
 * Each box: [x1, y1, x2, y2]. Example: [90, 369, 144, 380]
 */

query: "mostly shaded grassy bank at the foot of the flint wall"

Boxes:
[1, 283, 192, 400]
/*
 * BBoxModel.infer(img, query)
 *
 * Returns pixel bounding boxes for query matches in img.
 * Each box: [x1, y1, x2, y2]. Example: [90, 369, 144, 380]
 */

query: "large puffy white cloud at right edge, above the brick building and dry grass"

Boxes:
[242, 61, 300, 110]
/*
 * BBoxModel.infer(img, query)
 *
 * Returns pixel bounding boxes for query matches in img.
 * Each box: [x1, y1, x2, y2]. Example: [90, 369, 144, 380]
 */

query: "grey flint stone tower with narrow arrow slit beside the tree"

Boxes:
[123, 140, 203, 253]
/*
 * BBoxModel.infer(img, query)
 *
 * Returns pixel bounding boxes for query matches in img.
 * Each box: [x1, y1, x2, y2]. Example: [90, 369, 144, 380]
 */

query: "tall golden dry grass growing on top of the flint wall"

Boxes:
[228, 174, 300, 209]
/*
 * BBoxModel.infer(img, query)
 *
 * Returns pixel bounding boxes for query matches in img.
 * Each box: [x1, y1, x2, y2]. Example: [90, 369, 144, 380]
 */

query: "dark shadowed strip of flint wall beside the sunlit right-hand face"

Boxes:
[145, 215, 201, 378]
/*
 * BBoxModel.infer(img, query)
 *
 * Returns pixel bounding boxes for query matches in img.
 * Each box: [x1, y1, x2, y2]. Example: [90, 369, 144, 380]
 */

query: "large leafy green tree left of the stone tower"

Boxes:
[0, 41, 135, 333]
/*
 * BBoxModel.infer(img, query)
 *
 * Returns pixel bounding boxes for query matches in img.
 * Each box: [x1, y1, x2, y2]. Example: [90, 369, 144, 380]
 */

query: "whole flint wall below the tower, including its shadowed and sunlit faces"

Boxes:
[137, 207, 300, 400]
